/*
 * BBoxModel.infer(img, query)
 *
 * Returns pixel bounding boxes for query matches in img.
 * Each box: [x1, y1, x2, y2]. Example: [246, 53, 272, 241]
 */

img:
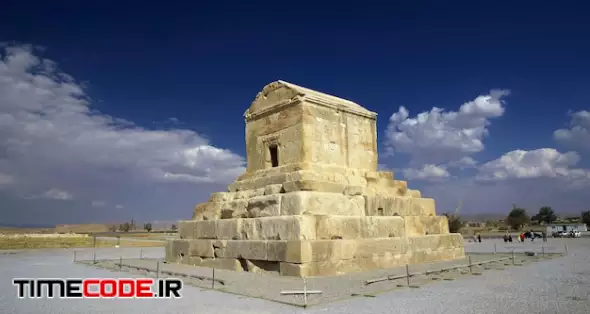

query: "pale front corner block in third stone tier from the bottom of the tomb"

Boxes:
[281, 191, 365, 216]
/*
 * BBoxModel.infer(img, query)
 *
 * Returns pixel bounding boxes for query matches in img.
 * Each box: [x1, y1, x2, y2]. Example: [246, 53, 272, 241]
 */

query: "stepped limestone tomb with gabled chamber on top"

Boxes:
[166, 81, 465, 277]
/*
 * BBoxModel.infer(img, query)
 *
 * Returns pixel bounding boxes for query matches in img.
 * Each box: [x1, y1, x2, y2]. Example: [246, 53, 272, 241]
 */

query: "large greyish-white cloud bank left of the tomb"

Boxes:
[0, 46, 245, 226]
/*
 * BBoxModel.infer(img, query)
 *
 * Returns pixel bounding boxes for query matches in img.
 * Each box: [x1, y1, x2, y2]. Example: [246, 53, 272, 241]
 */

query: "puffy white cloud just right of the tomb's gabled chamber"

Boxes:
[385, 90, 509, 165]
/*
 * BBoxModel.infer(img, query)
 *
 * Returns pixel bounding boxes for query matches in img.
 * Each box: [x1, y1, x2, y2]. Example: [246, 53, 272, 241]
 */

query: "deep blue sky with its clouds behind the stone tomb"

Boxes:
[0, 2, 590, 223]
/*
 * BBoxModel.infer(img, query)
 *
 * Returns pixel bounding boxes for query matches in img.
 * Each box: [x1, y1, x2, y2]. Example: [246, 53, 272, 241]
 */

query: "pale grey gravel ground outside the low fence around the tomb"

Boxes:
[0, 239, 590, 314]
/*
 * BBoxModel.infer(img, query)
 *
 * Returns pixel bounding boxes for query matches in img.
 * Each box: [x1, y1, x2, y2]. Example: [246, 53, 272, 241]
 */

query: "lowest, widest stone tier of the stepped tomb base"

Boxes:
[166, 234, 465, 277]
